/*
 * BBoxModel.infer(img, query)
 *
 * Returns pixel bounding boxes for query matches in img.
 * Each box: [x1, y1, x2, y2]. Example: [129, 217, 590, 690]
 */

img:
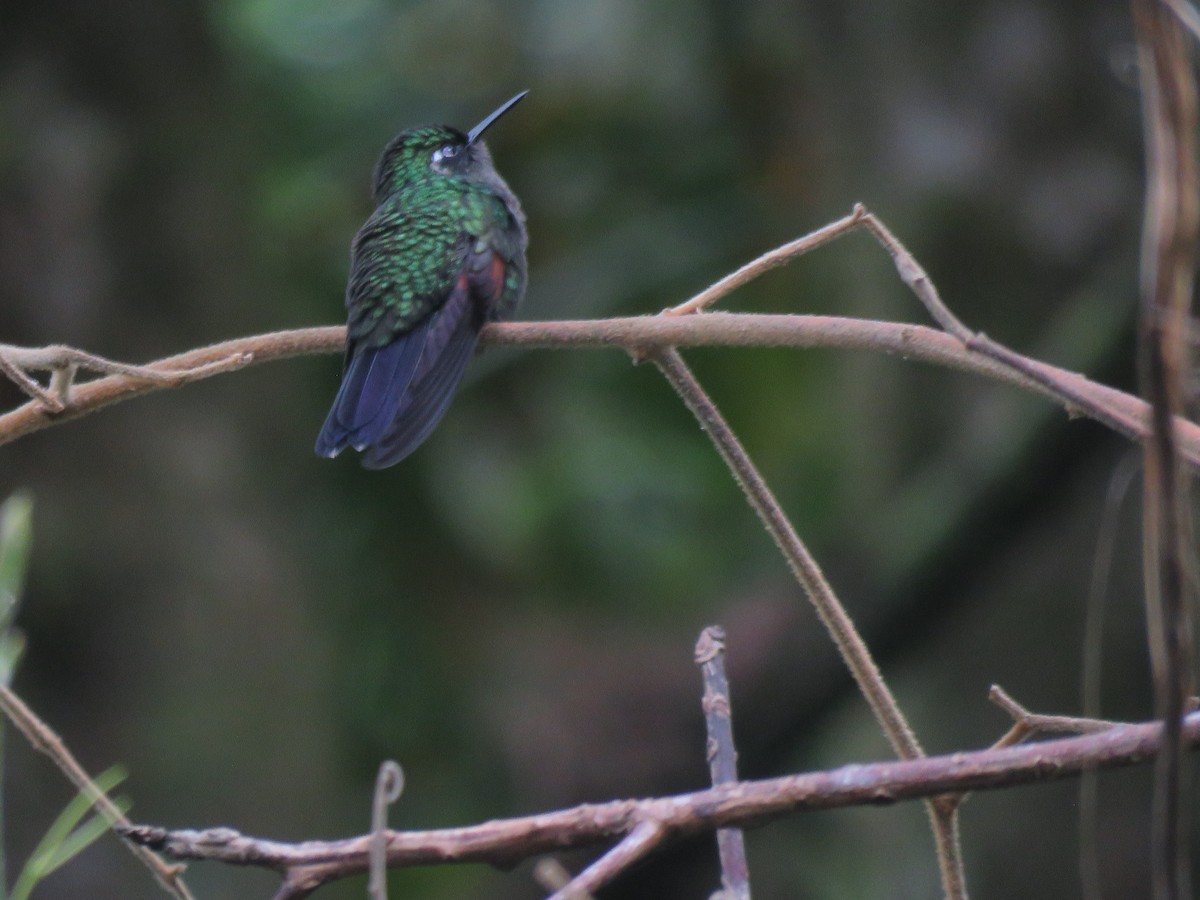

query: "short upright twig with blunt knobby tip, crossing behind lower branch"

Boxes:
[695, 625, 750, 900]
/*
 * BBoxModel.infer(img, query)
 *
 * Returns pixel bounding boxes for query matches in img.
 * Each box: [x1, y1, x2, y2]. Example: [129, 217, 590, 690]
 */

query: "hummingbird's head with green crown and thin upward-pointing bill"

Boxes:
[374, 91, 528, 200]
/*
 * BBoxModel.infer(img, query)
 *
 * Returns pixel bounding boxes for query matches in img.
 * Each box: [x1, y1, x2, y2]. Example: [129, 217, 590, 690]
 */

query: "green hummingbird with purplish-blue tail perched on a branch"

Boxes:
[316, 91, 529, 469]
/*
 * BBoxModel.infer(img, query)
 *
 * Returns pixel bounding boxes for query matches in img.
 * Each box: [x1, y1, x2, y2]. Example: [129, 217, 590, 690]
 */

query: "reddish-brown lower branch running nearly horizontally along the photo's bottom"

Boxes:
[121, 713, 1200, 888]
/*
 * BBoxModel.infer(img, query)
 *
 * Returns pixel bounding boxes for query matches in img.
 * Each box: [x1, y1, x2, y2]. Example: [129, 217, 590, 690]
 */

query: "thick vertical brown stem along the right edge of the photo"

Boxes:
[1133, 0, 1200, 900]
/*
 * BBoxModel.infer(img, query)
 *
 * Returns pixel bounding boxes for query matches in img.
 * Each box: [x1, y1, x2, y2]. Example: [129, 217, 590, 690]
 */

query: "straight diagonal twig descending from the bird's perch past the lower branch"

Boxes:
[652, 349, 967, 900]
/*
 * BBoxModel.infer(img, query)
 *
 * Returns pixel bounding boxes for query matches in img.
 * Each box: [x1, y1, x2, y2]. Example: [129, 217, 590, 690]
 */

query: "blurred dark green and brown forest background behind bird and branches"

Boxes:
[0, 0, 1190, 900]
